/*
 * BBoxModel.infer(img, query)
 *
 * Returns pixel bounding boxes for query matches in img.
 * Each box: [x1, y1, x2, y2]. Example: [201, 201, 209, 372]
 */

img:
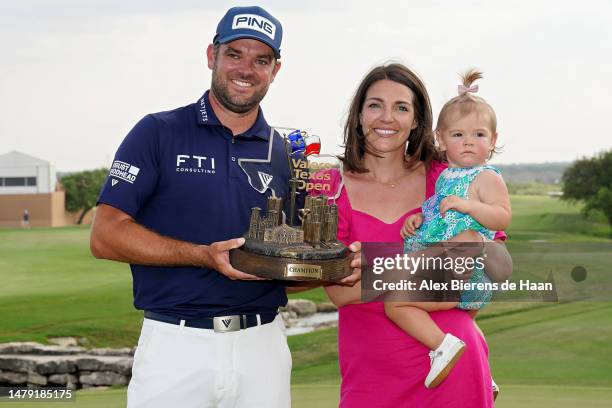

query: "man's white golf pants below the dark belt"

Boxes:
[127, 315, 291, 408]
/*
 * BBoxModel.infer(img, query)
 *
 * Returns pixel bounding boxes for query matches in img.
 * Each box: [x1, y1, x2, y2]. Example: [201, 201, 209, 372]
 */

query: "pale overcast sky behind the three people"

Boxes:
[0, 0, 612, 171]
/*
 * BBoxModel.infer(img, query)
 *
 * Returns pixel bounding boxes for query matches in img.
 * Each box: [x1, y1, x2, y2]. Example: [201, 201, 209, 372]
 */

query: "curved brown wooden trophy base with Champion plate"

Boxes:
[230, 248, 352, 282]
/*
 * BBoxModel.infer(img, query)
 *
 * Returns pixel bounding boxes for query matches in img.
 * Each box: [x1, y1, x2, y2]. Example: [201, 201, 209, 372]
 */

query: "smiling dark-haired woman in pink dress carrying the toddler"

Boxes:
[326, 64, 507, 408]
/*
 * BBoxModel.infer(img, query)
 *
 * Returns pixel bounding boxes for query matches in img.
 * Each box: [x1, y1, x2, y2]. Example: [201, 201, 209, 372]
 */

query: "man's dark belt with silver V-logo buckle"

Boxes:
[145, 311, 276, 333]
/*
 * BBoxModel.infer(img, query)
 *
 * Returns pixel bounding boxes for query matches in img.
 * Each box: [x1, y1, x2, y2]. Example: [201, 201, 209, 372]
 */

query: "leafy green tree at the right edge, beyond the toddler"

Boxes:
[563, 150, 612, 237]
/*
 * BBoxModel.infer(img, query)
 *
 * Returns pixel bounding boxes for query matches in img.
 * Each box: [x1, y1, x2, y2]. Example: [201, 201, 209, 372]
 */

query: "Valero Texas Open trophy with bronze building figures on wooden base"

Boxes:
[230, 128, 352, 282]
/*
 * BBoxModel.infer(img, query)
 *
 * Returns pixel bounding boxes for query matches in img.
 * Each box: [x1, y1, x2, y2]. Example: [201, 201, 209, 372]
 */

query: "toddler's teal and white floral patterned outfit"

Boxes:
[404, 165, 500, 310]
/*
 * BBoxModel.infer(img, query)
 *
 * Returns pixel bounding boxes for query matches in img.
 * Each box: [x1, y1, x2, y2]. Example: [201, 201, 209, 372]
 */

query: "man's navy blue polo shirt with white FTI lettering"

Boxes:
[98, 92, 289, 318]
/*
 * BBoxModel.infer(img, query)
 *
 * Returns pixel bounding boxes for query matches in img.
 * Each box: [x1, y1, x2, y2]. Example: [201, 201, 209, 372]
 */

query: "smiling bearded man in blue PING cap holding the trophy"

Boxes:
[91, 7, 359, 408]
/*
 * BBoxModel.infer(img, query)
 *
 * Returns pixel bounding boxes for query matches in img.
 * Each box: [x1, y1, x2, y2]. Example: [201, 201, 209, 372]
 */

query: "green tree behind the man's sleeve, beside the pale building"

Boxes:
[60, 169, 108, 224]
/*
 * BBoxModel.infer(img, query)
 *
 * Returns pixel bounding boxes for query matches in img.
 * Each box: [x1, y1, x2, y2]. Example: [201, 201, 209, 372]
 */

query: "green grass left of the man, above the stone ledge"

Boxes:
[0, 227, 142, 346]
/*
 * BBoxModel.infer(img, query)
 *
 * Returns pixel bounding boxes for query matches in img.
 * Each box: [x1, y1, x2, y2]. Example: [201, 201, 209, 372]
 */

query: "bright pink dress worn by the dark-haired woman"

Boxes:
[336, 162, 493, 408]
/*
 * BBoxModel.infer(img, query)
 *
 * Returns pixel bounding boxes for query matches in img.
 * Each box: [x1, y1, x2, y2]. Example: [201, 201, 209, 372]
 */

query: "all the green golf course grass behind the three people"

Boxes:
[0, 196, 612, 408]
